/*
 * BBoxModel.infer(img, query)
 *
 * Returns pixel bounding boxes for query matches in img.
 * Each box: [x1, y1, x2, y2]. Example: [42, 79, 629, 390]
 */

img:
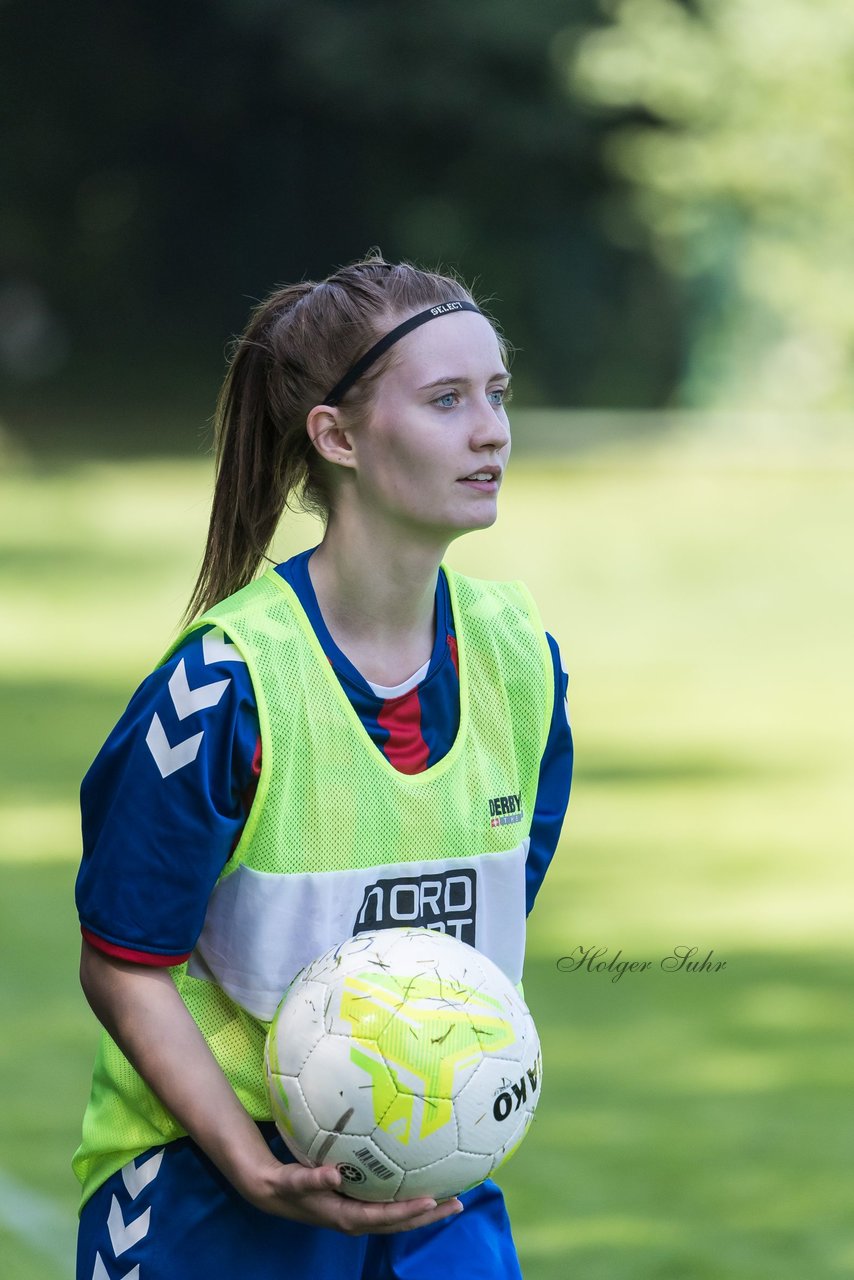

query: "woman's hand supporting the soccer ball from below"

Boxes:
[238, 1156, 462, 1235]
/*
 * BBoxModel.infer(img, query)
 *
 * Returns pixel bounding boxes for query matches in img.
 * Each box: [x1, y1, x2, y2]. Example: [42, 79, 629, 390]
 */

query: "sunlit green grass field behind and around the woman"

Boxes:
[0, 422, 854, 1280]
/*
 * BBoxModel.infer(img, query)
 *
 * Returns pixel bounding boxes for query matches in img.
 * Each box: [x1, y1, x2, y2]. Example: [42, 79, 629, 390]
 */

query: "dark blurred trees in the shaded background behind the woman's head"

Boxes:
[0, 0, 680, 448]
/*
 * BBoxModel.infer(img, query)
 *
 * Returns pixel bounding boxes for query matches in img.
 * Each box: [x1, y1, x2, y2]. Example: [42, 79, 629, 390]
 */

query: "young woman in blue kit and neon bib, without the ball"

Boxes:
[74, 257, 572, 1280]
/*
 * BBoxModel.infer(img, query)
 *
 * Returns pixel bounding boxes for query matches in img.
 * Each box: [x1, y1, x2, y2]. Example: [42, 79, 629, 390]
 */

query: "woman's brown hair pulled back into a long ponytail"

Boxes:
[184, 255, 496, 621]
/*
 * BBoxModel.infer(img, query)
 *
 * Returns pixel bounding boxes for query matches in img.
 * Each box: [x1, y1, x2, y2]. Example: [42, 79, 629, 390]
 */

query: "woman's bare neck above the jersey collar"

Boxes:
[310, 513, 447, 686]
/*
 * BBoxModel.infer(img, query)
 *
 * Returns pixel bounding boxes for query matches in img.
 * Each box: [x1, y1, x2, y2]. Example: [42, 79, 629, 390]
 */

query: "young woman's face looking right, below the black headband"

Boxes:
[352, 311, 510, 539]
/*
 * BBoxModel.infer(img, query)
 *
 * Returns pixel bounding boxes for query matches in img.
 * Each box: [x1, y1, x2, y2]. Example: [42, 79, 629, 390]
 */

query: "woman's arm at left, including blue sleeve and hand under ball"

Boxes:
[77, 637, 461, 1234]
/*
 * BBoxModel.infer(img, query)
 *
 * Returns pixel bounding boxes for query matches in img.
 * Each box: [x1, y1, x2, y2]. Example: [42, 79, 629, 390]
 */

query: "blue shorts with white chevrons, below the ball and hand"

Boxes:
[77, 1125, 521, 1280]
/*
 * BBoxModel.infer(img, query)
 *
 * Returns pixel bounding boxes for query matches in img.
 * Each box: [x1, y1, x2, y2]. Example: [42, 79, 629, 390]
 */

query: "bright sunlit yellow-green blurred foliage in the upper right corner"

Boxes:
[566, 0, 854, 408]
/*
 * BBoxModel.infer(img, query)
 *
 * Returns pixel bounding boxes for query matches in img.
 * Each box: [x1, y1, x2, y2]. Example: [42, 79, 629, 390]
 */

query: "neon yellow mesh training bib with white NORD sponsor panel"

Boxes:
[74, 570, 553, 1199]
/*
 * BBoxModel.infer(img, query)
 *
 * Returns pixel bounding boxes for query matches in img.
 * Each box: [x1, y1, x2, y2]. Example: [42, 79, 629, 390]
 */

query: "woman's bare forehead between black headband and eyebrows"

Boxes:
[389, 311, 506, 381]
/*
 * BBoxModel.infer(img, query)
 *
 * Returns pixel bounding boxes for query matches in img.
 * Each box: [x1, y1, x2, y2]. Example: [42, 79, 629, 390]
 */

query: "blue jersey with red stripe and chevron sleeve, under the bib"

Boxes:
[77, 550, 572, 965]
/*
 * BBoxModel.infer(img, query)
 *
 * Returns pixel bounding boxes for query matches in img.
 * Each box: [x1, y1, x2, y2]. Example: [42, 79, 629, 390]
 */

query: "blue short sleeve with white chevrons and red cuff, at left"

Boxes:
[76, 627, 260, 965]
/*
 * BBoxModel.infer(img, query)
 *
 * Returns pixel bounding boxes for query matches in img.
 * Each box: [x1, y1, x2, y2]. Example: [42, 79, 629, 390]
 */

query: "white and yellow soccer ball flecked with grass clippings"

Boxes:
[265, 929, 542, 1201]
